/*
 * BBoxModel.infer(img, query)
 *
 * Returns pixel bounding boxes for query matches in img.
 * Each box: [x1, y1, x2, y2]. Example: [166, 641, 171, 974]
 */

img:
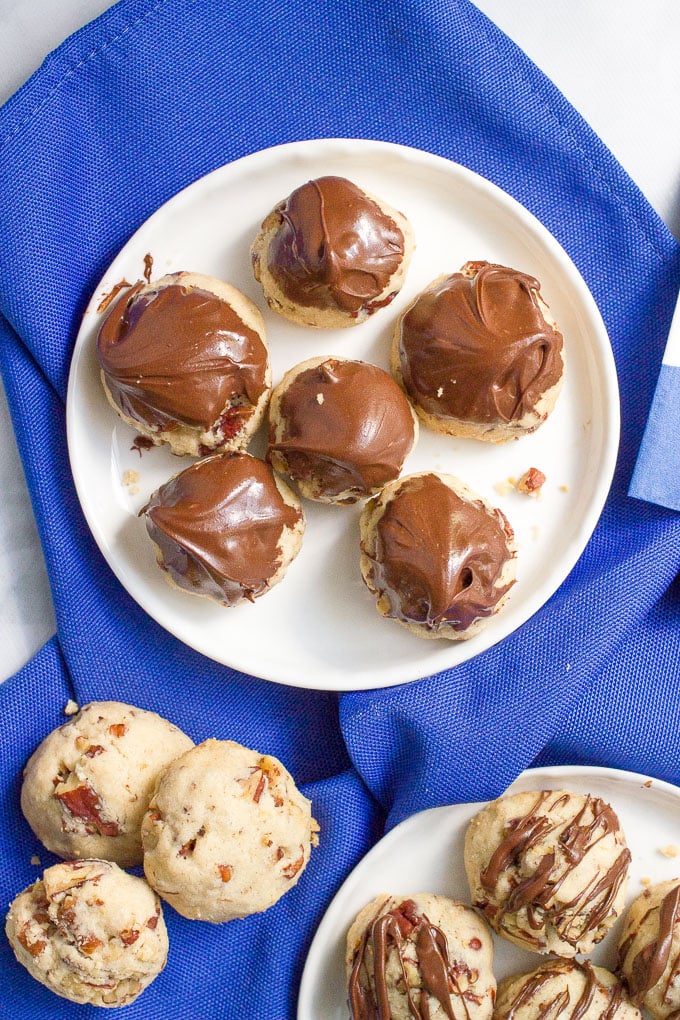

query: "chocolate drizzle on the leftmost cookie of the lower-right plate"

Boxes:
[349, 900, 478, 1020]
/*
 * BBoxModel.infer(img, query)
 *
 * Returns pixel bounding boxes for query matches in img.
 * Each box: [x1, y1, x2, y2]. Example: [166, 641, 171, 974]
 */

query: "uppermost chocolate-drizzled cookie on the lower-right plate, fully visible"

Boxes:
[465, 791, 630, 958]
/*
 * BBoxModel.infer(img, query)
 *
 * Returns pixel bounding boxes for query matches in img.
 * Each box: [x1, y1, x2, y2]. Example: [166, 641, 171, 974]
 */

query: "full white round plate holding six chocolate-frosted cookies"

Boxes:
[66, 140, 619, 691]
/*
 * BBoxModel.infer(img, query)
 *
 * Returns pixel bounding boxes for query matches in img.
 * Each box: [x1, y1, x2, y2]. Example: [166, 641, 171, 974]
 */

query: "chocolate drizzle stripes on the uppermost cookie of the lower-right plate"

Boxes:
[476, 791, 630, 947]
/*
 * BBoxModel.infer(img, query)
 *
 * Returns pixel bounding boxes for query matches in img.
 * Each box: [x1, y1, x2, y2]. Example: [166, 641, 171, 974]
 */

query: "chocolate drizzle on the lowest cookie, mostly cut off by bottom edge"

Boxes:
[493, 960, 623, 1020]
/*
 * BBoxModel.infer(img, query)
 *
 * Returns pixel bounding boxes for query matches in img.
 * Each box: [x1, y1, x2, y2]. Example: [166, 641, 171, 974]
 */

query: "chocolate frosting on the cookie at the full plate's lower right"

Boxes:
[364, 474, 512, 630]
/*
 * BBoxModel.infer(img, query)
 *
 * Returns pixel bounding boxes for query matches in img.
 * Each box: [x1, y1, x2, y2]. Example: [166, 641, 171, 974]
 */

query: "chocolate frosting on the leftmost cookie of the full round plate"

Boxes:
[97, 282, 268, 431]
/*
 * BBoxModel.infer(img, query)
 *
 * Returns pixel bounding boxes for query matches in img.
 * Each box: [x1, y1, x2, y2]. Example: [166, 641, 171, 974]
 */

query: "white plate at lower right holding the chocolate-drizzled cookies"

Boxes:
[298, 766, 680, 1020]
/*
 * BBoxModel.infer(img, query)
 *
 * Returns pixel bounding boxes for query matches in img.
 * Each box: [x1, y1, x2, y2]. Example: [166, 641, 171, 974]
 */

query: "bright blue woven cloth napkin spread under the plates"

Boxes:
[0, 0, 680, 1020]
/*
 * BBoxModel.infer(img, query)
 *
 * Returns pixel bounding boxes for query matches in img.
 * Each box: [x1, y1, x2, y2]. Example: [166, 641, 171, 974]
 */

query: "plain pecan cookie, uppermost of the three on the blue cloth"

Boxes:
[21, 702, 194, 867]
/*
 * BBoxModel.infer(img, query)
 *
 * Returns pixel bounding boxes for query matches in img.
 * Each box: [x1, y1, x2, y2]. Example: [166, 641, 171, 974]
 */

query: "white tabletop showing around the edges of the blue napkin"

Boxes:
[0, 0, 680, 680]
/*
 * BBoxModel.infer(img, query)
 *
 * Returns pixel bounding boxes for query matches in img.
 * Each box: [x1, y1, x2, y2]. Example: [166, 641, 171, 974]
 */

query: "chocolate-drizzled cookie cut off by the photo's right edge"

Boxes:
[618, 878, 680, 1020]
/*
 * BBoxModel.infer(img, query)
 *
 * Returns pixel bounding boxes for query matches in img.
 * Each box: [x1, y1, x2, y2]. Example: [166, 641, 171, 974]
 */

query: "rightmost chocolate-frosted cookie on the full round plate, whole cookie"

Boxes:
[391, 262, 565, 443]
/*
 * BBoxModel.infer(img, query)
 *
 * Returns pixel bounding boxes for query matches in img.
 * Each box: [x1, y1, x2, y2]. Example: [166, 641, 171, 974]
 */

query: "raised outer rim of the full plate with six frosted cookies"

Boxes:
[66, 137, 621, 693]
